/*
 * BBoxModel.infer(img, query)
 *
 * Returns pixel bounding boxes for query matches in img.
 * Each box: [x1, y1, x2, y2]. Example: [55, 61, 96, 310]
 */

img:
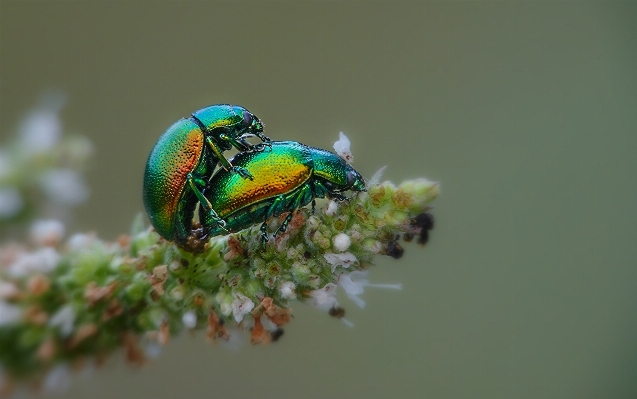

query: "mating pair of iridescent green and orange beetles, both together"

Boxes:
[143, 104, 365, 252]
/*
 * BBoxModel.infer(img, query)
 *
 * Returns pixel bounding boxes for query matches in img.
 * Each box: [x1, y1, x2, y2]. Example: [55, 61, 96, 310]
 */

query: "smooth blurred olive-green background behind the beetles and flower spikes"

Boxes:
[0, 0, 637, 399]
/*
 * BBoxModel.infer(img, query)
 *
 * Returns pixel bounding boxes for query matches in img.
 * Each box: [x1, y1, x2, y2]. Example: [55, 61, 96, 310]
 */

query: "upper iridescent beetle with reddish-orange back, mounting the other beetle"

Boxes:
[143, 104, 270, 251]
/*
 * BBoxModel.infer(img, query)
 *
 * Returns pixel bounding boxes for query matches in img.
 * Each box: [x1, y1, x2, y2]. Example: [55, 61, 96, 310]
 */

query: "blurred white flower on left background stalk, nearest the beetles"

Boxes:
[40, 169, 89, 205]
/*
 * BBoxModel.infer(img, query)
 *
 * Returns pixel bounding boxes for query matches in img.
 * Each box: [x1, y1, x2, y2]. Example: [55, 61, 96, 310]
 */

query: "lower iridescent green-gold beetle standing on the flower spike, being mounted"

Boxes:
[199, 141, 365, 246]
